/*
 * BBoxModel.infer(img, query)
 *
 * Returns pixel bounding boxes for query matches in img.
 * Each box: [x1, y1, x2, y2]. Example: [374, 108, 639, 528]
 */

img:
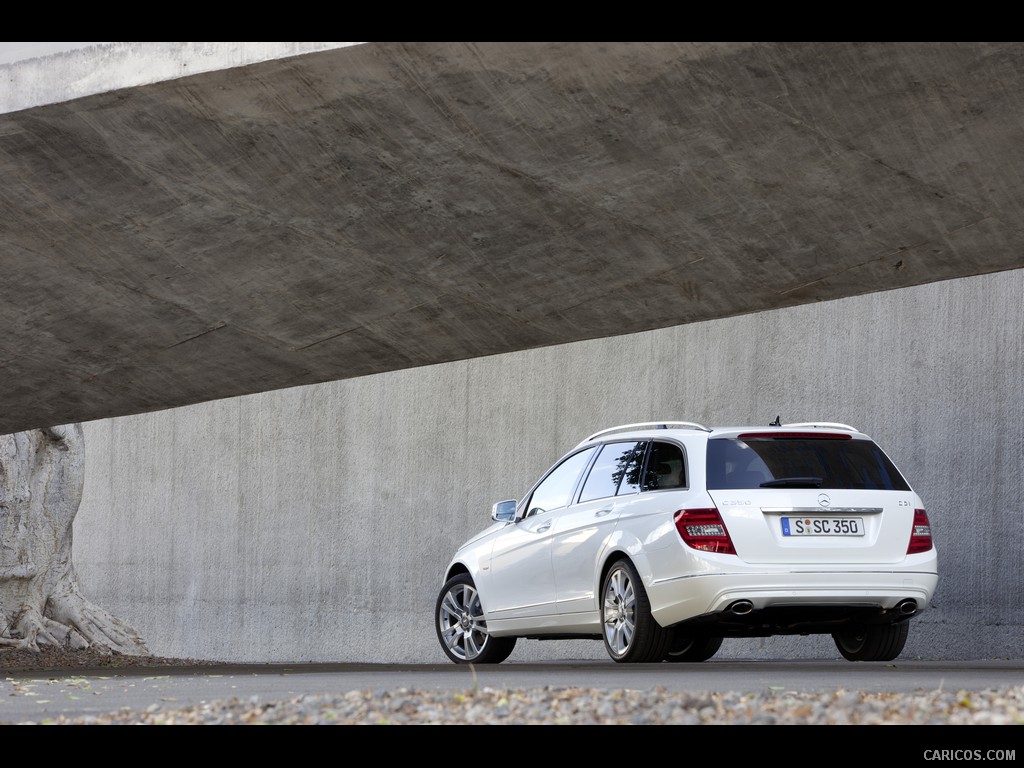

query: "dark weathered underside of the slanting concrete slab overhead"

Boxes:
[0, 43, 1024, 436]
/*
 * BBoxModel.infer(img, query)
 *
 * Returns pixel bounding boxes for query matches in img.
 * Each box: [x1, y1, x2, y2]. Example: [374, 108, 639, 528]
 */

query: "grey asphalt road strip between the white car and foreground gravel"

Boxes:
[0, 659, 1024, 724]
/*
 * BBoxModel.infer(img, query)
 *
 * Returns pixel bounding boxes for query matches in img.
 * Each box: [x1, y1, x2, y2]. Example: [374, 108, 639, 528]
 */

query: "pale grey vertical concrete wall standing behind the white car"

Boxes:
[75, 271, 1024, 663]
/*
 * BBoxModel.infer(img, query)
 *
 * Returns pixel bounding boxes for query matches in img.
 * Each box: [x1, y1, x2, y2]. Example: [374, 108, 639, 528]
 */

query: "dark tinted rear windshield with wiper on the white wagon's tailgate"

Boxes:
[708, 438, 909, 490]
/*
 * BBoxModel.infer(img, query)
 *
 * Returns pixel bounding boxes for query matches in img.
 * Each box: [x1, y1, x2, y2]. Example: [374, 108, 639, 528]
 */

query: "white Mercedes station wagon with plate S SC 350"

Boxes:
[434, 419, 938, 664]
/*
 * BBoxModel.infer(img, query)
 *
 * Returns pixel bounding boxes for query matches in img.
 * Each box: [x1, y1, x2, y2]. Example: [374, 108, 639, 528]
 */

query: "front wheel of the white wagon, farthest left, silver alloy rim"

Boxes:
[434, 573, 516, 664]
